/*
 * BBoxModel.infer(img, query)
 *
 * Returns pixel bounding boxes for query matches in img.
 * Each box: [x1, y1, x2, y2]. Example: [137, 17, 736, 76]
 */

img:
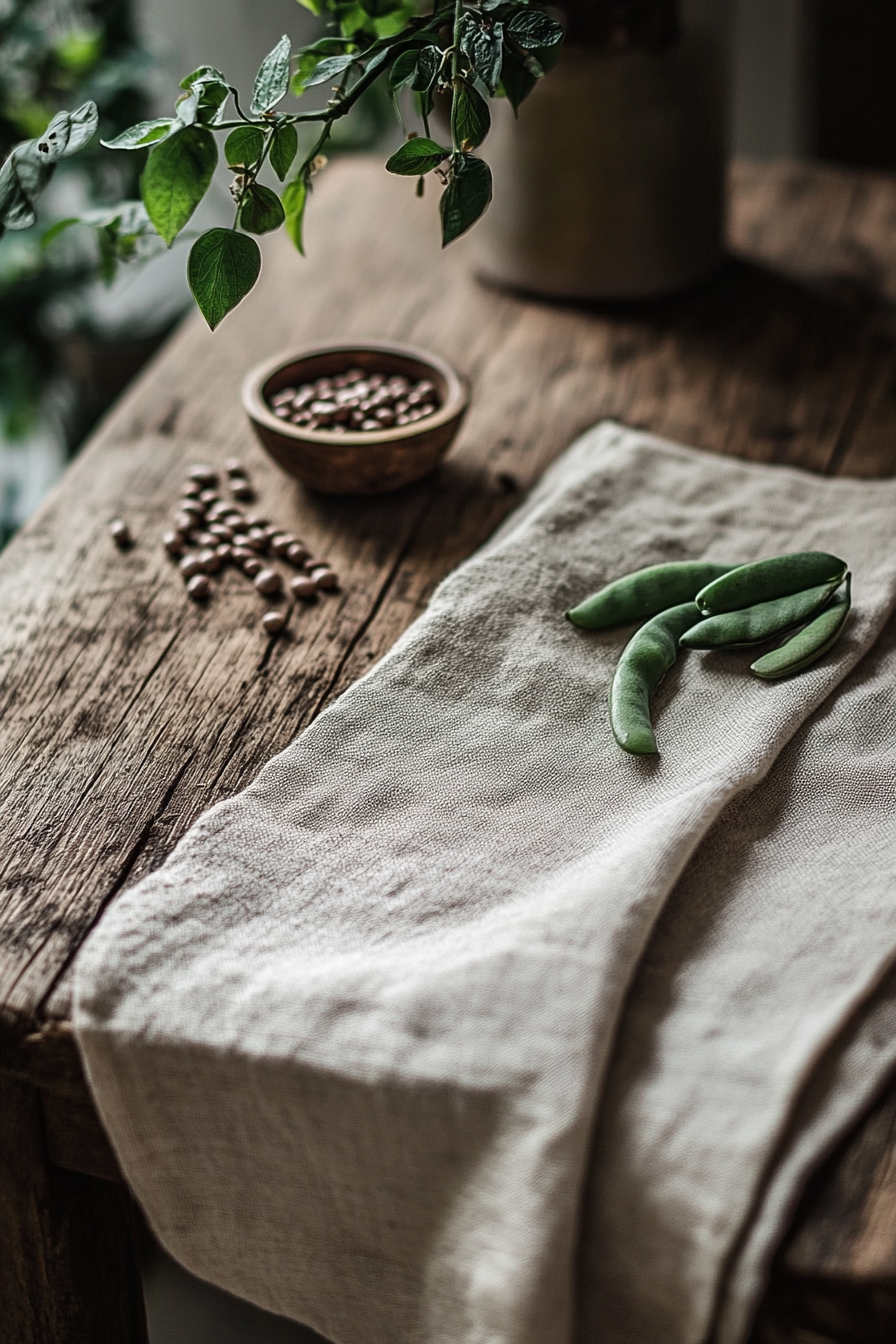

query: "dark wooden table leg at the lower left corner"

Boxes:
[0, 1073, 148, 1344]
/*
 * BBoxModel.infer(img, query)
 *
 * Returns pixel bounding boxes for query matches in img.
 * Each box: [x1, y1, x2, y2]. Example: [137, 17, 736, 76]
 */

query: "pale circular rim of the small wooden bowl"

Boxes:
[242, 340, 469, 448]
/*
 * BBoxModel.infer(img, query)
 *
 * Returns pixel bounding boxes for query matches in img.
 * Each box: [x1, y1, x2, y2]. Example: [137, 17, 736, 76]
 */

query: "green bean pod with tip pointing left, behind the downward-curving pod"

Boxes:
[566, 560, 736, 630]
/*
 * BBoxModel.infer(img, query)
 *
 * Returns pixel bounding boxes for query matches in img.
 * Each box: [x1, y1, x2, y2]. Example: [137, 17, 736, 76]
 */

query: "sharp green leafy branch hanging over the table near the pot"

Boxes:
[0, 0, 563, 328]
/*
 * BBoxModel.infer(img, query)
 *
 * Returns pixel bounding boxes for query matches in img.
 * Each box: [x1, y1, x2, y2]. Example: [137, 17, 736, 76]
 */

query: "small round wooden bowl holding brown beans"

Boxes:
[243, 341, 467, 495]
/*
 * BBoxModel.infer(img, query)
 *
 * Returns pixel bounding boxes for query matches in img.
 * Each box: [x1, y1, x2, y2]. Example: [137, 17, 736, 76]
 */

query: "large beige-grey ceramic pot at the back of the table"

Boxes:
[474, 0, 729, 300]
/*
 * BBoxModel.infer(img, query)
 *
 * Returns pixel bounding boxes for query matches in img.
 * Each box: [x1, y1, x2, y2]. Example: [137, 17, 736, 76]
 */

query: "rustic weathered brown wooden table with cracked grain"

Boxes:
[0, 160, 896, 1344]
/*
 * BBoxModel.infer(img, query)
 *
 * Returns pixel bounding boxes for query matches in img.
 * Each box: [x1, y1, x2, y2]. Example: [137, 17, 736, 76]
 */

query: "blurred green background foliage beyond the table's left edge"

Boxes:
[0, 0, 153, 438]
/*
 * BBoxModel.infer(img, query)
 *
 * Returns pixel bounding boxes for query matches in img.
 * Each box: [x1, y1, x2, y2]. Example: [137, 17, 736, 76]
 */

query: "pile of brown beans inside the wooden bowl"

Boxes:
[267, 368, 439, 434]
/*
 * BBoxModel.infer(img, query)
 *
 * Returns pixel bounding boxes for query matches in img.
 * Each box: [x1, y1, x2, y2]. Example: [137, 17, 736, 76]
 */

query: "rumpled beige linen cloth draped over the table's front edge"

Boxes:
[74, 423, 896, 1344]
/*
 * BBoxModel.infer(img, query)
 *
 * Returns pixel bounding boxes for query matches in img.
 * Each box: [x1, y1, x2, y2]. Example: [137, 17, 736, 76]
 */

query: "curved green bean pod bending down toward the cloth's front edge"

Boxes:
[610, 602, 700, 755]
